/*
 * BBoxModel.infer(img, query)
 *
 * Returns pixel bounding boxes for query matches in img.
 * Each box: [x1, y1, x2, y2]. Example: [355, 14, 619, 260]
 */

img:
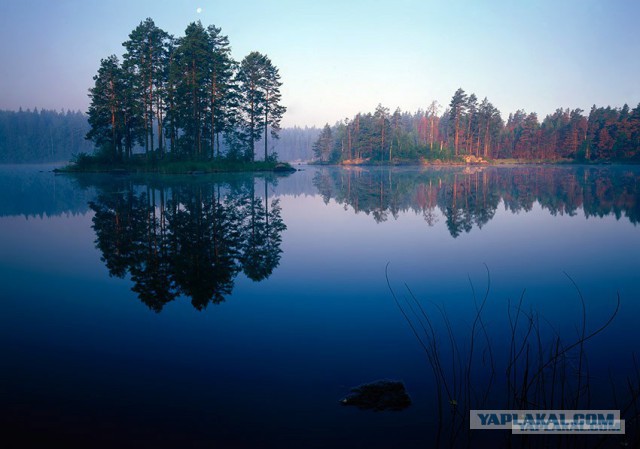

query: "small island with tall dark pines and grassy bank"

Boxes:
[61, 18, 295, 174]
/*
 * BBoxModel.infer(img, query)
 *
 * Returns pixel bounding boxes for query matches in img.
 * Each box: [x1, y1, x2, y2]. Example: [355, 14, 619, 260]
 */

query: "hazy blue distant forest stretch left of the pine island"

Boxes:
[0, 109, 93, 164]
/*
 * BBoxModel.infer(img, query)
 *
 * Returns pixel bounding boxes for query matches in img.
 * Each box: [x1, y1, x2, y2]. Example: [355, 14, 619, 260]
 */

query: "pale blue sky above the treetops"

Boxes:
[0, 0, 640, 126]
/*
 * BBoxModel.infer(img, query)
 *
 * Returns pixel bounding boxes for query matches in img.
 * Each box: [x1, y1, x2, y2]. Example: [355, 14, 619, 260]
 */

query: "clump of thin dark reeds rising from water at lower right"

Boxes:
[385, 264, 640, 447]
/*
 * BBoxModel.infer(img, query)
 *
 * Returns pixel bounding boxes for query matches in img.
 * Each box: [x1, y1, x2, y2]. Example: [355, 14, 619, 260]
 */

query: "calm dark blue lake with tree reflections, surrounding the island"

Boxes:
[0, 166, 640, 448]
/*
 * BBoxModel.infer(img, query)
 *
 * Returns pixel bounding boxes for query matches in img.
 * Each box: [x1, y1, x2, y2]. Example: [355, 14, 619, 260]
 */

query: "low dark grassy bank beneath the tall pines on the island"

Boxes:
[57, 154, 296, 174]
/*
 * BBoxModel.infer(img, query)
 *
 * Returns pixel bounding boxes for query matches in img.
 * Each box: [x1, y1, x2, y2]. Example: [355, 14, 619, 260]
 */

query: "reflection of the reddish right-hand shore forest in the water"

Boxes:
[314, 166, 640, 234]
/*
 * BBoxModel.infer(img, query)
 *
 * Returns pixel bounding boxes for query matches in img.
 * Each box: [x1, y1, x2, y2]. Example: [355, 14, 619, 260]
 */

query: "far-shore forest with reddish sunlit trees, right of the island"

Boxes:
[313, 89, 640, 163]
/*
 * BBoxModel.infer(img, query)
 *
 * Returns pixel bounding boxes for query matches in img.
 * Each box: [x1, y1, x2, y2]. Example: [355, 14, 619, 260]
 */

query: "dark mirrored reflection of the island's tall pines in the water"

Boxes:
[90, 178, 286, 312]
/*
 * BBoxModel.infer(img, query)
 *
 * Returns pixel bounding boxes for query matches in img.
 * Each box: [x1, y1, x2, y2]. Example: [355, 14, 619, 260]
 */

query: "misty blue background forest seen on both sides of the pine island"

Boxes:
[0, 109, 320, 164]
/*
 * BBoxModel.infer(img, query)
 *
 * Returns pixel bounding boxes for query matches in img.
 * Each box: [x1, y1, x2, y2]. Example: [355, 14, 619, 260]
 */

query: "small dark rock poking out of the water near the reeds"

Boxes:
[340, 380, 411, 411]
